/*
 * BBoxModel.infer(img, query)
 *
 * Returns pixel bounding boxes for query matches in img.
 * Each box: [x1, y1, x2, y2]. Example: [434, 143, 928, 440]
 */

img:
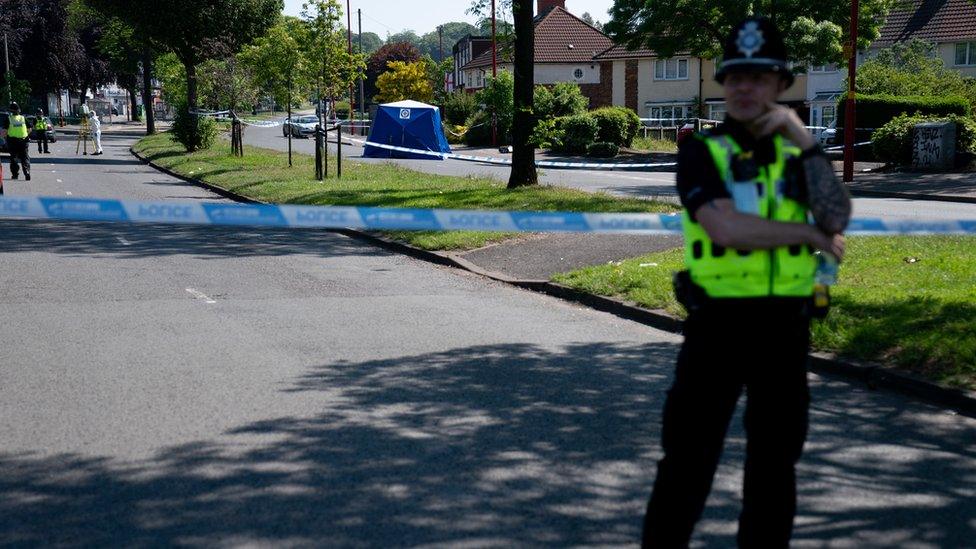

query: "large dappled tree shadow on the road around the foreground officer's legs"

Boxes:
[0, 343, 976, 547]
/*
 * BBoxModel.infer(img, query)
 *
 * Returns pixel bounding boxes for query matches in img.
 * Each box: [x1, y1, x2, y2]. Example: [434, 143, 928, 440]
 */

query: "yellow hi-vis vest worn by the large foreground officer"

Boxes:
[683, 135, 817, 298]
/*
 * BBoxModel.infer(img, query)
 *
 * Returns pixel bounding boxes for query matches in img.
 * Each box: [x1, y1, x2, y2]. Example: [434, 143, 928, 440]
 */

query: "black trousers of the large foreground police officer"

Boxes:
[643, 300, 810, 549]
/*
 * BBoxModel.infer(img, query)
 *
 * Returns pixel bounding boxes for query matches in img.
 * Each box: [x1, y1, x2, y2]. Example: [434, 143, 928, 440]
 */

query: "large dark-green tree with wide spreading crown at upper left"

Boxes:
[89, 0, 284, 110]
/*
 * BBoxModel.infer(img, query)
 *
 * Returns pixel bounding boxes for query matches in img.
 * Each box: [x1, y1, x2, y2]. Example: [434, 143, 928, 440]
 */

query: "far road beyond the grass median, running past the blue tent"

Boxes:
[244, 127, 976, 219]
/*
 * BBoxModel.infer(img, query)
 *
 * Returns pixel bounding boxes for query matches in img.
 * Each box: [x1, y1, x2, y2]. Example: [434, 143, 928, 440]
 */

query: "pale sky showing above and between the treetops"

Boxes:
[285, 0, 613, 39]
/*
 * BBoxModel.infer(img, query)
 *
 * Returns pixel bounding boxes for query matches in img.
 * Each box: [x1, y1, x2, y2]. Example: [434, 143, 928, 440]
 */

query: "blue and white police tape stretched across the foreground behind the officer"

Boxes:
[0, 196, 976, 235]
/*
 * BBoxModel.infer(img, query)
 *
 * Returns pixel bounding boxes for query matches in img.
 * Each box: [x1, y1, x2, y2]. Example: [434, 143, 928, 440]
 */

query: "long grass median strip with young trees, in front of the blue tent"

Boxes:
[134, 133, 675, 250]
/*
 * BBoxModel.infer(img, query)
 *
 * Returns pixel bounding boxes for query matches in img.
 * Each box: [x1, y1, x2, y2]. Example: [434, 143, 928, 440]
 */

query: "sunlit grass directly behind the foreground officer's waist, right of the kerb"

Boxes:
[554, 236, 976, 389]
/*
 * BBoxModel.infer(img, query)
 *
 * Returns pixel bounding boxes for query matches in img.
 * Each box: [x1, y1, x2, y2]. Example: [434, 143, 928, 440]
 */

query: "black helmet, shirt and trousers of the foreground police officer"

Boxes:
[643, 19, 822, 549]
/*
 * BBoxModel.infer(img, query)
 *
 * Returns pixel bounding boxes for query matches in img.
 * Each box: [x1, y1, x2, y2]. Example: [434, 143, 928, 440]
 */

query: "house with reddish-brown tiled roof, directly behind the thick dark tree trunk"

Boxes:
[461, 0, 613, 108]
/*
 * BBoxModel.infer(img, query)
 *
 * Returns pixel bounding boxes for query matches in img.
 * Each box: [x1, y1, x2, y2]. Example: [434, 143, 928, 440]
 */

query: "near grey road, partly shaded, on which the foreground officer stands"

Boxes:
[0, 131, 976, 548]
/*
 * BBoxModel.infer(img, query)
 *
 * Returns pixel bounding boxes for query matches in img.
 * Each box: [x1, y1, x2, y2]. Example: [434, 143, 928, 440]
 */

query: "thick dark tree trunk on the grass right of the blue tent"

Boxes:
[508, 0, 539, 189]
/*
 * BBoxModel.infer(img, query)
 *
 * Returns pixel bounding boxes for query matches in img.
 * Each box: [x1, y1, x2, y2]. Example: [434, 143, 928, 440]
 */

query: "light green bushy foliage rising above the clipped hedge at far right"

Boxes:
[856, 39, 976, 110]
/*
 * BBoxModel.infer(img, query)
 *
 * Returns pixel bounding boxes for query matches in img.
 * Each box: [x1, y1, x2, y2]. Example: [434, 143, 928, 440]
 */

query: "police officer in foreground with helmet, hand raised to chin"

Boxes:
[643, 17, 851, 548]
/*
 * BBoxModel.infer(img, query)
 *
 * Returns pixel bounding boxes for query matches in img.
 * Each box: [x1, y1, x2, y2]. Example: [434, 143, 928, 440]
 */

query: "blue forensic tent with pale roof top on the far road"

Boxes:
[363, 101, 451, 160]
